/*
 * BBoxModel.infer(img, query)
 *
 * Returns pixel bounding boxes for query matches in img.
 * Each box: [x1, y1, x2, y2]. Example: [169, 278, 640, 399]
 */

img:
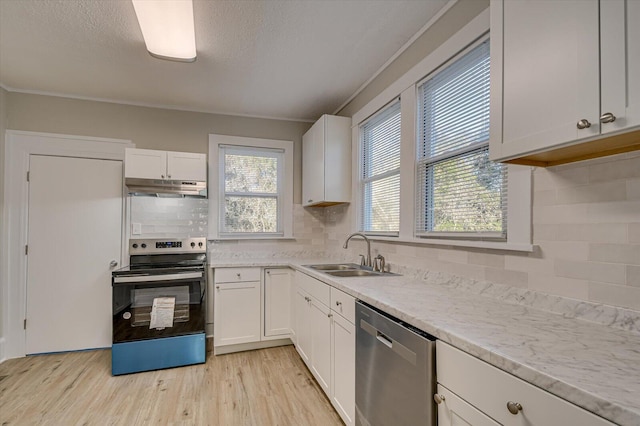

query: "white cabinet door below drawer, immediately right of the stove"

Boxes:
[213, 281, 260, 346]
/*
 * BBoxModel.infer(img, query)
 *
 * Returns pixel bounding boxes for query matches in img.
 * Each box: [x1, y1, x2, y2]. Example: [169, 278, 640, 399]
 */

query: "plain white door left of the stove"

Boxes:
[26, 155, 123, 354]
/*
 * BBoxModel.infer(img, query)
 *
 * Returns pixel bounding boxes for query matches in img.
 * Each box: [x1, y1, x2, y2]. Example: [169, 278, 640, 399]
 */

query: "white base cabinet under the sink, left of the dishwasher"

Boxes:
[294, 273, 356, 425]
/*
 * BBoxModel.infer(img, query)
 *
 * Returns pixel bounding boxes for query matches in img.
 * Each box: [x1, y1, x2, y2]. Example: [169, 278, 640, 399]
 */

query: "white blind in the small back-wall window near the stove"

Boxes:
[219, 145, 284, 236]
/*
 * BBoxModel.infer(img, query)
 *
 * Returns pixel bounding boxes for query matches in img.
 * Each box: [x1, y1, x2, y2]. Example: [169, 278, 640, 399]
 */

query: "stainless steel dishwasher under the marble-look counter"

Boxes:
[356, 301, 436, 426]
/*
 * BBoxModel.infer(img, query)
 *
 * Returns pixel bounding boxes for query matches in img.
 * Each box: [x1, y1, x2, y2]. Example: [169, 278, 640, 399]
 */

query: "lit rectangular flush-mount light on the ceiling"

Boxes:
[131, 0, 196, 62]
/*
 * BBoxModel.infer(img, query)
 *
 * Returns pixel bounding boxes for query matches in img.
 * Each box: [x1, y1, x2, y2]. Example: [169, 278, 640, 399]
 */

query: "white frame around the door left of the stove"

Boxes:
[0, 130, 135, 362]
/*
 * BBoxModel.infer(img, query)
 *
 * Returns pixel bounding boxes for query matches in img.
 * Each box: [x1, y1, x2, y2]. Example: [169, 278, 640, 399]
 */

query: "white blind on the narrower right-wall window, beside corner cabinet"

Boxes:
[360, 100, 400, 235]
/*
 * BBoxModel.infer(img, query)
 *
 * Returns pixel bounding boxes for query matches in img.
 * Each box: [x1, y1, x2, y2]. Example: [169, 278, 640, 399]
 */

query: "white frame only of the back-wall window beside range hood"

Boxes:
[208, 134, 293, 240]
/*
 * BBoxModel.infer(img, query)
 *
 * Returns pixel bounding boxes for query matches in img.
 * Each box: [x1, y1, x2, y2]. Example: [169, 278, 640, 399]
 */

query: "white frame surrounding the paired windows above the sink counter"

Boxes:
[351, 9, 534, 252]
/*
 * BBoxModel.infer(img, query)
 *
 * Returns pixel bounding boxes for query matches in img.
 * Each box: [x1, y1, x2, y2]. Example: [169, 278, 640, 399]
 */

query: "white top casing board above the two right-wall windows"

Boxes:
[351, 9, 489, 127]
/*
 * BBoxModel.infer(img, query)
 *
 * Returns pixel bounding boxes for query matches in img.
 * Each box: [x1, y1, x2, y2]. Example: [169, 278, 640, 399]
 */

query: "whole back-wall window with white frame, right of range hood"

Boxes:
[209, 135, 293, 239]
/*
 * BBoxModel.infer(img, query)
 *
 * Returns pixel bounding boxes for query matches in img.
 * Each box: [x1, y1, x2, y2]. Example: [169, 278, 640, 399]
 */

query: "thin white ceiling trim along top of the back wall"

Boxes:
[0, 84, 315, 123]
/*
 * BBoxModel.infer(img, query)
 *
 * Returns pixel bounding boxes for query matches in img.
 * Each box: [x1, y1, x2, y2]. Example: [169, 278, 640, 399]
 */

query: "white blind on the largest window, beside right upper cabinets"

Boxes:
[416, 40, 507, 239]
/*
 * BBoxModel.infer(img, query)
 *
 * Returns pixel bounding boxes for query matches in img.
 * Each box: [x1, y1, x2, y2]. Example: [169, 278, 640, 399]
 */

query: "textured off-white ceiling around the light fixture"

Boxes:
[0, 0, 447, 120]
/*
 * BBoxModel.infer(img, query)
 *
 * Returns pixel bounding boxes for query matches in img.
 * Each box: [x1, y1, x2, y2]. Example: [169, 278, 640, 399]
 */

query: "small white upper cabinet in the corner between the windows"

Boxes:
[302, 114, 351, 207]
